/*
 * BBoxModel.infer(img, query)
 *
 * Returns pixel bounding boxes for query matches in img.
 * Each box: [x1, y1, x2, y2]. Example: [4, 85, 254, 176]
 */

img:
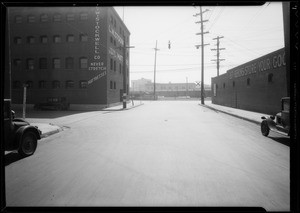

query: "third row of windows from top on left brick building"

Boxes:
[13, 57, 88, 70]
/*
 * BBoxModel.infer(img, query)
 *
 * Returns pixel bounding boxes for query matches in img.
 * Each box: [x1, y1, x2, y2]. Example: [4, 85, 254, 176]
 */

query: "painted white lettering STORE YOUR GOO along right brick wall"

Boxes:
[227, 51, 286, 79]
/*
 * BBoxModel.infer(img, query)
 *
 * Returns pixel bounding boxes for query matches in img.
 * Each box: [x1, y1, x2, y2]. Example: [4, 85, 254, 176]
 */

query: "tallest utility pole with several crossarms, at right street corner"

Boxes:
[194, 6, 209, 104]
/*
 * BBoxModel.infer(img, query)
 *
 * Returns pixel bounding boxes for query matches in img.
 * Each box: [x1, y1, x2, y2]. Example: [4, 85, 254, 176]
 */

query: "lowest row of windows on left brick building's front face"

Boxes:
[12, 80, 87, 89]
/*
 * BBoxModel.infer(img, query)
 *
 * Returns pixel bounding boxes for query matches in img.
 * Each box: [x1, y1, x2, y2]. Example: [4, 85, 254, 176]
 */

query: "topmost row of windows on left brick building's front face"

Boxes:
[14, 13, 88, 24]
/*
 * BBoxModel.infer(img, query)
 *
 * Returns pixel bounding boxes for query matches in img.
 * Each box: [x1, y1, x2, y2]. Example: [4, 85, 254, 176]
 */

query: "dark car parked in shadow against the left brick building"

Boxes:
[34, 97, 70, 110]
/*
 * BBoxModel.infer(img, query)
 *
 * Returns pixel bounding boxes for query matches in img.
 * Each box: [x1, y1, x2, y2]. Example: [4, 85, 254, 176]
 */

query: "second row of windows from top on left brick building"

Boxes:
[14, 34, 88, 44]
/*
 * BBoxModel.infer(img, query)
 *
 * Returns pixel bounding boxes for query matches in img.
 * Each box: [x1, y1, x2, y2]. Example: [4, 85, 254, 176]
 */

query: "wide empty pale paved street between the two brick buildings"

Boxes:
[5, 101, 290, 211]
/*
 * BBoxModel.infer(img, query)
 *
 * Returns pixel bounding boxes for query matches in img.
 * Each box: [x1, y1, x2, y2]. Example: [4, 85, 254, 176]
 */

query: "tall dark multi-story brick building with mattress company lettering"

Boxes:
[6, 7, 130, 108]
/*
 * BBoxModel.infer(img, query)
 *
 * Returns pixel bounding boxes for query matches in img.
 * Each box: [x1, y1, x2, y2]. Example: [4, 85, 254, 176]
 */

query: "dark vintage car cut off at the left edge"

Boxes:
[3, 99, 41, 157]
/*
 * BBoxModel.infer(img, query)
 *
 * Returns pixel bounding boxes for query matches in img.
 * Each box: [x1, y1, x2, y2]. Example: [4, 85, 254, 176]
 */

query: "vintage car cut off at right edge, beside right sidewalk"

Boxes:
[261, 97, 290, 136]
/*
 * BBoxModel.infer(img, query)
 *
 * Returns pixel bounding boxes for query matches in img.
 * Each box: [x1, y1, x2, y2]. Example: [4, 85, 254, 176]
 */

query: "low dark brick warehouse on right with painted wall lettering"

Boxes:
[211, 48, 289, 114]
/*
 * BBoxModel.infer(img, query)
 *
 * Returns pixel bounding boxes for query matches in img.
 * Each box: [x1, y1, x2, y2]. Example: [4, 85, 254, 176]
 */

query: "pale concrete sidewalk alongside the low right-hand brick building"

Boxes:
[199, 101, 269, 124]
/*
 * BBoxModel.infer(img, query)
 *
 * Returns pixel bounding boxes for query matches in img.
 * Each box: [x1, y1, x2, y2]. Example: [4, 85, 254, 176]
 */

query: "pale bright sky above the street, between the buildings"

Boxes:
[114, 2, 284, 85]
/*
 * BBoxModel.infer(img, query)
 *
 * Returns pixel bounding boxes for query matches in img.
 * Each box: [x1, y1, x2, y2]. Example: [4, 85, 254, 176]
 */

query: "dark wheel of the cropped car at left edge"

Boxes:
[18, 131, 37, 157]
